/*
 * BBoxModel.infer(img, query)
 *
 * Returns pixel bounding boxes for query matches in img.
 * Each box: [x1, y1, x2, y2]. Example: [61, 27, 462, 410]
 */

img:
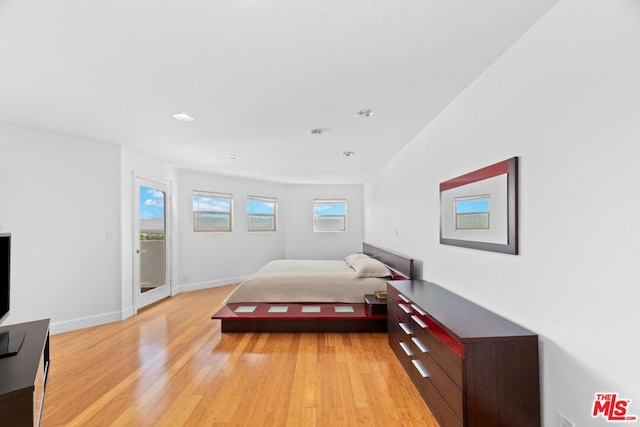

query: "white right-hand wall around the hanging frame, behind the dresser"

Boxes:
[365, 0, 640, 426]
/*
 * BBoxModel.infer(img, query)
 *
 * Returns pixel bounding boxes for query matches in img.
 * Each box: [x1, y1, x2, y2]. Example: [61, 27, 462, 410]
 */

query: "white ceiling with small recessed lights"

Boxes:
[0, 0, 557, 184]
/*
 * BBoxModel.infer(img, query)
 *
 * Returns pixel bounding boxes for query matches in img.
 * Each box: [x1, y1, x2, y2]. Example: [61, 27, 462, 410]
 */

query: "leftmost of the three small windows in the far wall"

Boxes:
[193, 191, 233, 231]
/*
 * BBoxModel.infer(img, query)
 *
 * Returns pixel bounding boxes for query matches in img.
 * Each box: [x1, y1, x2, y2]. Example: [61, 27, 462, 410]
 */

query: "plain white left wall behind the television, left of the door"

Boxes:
[0, 125, 120, 332]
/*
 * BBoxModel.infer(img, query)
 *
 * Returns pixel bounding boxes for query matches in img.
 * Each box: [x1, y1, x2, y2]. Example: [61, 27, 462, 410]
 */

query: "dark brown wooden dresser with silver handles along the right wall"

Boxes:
[387, 280, 540, 427]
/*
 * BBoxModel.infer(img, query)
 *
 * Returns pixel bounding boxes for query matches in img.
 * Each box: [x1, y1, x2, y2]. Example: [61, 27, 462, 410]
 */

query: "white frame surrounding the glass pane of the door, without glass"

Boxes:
[131, 171, 173, 314]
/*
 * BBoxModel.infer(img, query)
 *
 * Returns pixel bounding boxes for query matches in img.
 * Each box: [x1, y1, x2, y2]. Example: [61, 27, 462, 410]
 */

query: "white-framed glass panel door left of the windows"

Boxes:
[134, 177, 170, 309]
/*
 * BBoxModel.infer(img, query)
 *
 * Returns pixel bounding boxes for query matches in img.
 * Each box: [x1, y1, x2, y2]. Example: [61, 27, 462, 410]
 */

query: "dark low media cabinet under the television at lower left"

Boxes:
[0, 319, 49, 427]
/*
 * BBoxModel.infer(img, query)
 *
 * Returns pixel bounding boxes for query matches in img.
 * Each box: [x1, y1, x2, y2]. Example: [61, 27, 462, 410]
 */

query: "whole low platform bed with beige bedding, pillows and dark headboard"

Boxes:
[212, 243, 413, 332]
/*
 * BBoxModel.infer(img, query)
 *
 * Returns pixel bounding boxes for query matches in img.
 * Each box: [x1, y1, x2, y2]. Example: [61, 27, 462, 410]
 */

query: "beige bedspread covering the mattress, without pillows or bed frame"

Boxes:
[225, 260, 388, 304]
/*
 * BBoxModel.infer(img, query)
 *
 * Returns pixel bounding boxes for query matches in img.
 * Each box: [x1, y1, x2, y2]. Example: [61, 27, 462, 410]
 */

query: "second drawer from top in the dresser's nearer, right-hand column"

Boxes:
[412, 316, 464, 390]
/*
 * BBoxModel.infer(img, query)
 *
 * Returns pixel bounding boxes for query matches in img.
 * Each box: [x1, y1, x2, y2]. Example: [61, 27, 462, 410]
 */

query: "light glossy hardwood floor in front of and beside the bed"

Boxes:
[42, 286, 437, 427]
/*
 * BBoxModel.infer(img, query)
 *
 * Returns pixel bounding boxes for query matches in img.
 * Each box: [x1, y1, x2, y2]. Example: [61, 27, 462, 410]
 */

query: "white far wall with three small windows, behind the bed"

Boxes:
[175, 170, 363, 290]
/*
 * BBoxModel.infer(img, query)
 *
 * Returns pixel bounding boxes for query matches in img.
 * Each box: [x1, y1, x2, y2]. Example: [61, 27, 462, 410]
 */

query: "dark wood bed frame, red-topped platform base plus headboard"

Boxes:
[211, 243, 414, 332]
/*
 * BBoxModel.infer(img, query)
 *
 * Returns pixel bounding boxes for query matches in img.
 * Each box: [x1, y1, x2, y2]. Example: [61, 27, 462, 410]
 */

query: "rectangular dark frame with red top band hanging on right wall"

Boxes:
[440, 157, 518, 255]
